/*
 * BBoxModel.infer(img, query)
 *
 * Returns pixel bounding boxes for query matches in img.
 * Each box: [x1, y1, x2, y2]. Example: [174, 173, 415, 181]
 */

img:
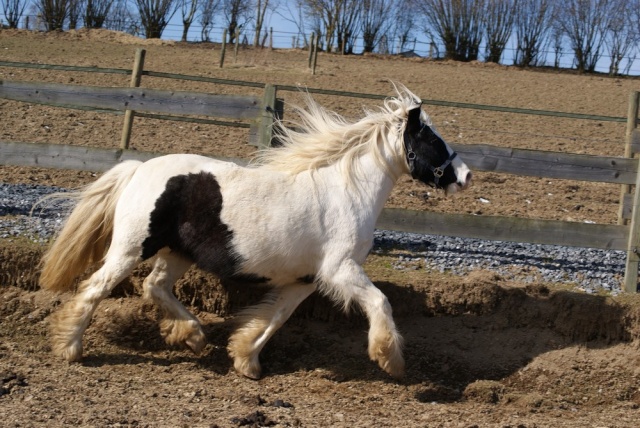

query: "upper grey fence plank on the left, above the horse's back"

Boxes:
[0, 80, 260, 119]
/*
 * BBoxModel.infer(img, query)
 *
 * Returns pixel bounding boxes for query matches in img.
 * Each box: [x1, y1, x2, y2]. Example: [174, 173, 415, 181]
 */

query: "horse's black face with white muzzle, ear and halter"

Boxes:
[404, 107, 471, 193]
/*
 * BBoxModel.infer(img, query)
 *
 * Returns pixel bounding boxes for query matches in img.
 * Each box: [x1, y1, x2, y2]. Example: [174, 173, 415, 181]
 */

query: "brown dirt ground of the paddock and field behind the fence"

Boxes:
[0, 30, 640, 427]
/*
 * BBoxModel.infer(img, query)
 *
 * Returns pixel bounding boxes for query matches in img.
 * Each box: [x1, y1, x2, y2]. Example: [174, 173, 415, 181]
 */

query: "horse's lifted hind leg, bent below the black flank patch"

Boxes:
[143, 249, 206, 354]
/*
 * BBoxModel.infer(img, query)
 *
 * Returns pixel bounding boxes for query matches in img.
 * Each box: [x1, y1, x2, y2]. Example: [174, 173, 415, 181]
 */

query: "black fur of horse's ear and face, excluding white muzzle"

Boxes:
[404, 107, 458, 187]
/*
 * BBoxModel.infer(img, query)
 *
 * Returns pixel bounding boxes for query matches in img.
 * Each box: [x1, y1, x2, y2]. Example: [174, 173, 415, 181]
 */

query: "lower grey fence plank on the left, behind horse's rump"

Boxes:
[0, 142, 246, 172]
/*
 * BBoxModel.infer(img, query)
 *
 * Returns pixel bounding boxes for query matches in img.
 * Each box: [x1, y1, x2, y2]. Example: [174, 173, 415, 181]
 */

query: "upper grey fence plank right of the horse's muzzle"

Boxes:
[451, 144, 638, 184]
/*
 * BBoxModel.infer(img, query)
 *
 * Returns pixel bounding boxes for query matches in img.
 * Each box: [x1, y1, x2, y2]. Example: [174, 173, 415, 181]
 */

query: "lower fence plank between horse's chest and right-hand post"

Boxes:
[376, 208, 629, 250]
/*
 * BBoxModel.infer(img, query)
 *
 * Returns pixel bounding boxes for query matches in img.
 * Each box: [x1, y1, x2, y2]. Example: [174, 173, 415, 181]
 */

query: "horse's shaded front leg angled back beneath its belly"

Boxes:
[227, 284, 316, 379]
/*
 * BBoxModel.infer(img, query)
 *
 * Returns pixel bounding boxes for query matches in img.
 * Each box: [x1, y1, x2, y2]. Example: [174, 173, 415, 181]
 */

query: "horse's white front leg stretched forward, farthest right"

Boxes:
[328, 260, 404, 378]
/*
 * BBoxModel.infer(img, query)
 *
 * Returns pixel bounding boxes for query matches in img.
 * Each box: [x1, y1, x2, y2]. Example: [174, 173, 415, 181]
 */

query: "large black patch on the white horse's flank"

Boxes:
[142, 172, 268, 282]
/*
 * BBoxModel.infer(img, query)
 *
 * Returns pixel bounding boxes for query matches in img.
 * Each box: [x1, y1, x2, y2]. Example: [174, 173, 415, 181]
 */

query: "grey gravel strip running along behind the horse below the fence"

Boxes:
[0, 184, 625, 294]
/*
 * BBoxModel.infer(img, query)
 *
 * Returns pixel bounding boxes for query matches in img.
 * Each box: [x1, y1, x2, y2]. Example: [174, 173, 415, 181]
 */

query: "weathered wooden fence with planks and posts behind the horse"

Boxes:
[0, 50, 640, 292]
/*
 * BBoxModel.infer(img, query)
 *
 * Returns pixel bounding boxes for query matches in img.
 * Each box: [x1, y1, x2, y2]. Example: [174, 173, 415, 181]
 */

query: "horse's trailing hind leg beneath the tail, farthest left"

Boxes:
[50, 251, 138, 361]
